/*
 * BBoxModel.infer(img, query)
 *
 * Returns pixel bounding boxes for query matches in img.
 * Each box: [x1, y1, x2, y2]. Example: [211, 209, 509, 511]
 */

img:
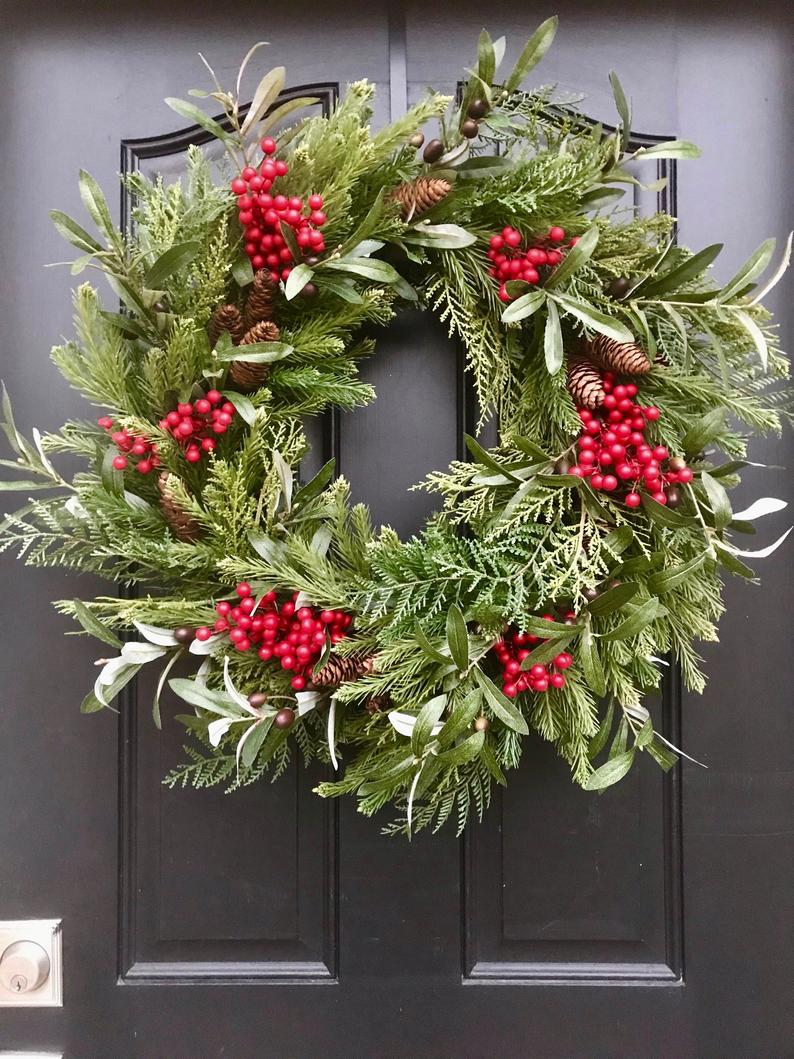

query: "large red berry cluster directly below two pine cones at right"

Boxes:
[569, 372, 693, 507]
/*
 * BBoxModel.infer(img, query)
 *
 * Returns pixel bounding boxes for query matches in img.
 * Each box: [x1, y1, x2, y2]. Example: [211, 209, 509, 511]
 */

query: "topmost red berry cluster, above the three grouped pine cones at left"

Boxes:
[232, 137, 327, 283]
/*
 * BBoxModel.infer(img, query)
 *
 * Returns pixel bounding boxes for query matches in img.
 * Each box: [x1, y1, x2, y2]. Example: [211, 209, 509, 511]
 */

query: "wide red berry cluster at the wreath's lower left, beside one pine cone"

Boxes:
[196, 581, 353, 692]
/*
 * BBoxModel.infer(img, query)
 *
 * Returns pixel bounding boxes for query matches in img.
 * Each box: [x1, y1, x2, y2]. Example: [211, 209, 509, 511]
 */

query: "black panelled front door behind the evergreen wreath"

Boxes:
[0, 0, 794, 1059]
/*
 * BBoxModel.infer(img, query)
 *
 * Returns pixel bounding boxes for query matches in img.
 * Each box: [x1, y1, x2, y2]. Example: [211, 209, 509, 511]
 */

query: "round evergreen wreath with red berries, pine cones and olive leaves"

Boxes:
[2, 19, 791, 833]
